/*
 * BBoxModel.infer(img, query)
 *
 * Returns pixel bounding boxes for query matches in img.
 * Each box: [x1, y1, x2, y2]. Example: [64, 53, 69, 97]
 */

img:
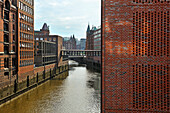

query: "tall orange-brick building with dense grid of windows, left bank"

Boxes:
[16, 0, 34, 80]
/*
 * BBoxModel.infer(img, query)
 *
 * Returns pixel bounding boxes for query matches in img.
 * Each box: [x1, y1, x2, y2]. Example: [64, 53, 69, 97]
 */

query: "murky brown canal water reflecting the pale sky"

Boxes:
[0, 61, 101, 113]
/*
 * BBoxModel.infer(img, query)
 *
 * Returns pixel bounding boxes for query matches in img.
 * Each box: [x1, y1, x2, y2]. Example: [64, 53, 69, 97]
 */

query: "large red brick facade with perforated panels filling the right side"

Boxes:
[102, 0, 170, 113]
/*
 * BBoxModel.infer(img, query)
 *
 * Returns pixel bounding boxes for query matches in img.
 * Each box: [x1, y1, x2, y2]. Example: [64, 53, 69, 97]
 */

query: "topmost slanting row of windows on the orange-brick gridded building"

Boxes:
[19, 2, 34, 15]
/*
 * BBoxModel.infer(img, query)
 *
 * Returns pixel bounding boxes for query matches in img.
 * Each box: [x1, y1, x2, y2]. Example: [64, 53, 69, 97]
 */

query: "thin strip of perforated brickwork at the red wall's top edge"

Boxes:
[133, 0, 170, 3]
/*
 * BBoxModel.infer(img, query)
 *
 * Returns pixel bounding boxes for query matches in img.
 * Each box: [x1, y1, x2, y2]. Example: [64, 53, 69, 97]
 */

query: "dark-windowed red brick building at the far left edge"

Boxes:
[0, 0, 17, 86]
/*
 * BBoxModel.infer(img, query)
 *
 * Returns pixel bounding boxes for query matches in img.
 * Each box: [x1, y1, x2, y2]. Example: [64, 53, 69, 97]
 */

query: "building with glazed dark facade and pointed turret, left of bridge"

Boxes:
[34, 23, 63, 66]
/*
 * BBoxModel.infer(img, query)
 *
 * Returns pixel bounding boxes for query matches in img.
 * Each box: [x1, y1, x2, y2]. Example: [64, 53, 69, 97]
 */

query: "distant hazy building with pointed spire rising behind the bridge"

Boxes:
[63, 35, 76, 49]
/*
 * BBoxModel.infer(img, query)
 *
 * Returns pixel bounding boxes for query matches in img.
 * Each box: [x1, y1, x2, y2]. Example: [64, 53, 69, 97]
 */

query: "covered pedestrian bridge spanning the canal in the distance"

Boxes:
[61, 49, 101, 57]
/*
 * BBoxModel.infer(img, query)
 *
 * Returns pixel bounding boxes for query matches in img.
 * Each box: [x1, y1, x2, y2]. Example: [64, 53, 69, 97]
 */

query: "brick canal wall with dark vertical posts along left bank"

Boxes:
[0, 63, 69, 105]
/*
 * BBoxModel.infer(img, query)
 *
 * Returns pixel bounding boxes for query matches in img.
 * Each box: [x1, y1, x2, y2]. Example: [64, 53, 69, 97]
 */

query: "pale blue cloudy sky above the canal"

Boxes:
[34, 0, 101, 39]
